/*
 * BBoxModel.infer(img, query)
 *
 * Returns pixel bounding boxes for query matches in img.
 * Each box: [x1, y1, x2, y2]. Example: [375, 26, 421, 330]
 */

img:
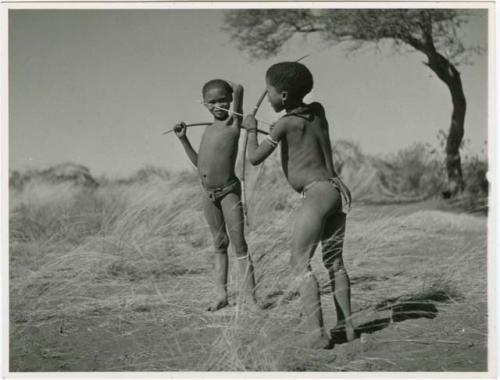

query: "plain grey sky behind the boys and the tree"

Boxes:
[9, 9, 488, 177]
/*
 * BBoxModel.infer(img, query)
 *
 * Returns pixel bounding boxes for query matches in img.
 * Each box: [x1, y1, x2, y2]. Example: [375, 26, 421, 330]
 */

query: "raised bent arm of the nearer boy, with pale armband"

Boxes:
[243, 115, 286, 165]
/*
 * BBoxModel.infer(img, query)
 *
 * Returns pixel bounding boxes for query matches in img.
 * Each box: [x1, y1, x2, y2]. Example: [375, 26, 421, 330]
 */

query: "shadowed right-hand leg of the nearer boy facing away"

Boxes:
[321, 213, 356, 342]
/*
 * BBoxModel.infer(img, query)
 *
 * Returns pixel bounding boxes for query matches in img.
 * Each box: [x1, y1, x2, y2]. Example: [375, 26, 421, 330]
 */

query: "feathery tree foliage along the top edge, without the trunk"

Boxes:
[223, 9, 480, 65]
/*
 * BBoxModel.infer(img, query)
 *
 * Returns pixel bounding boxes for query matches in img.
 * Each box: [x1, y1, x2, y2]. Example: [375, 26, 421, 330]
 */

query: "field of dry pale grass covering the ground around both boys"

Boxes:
[9, 142, 488, 371]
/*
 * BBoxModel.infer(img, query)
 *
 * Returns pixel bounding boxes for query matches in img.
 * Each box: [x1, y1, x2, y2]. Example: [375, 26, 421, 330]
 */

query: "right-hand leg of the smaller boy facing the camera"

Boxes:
[221, 193, 258, 308]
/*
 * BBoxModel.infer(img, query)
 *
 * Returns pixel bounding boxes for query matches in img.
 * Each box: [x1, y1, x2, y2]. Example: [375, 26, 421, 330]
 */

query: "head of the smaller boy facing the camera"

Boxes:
[201, 79, 233, 120]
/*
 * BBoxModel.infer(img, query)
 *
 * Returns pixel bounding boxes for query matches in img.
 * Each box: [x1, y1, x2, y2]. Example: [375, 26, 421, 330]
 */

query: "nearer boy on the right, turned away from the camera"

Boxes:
[243, 62, 355, 348]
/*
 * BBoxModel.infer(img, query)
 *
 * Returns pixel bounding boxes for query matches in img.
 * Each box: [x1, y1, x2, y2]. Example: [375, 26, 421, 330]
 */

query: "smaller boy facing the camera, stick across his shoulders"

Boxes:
[174, 79, 257, 311]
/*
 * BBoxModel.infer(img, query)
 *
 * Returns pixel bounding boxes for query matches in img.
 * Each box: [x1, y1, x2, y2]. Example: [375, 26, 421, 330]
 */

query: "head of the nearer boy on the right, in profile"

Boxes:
[266, 62, 313, 111]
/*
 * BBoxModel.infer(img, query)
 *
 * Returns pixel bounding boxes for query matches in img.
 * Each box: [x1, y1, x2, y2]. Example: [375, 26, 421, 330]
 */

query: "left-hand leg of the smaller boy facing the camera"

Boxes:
[203, 194, 229, 311]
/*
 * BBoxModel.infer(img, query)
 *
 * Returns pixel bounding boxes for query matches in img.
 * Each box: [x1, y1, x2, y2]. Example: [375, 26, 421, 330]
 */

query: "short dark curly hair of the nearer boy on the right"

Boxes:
[266, 62, 313, 98]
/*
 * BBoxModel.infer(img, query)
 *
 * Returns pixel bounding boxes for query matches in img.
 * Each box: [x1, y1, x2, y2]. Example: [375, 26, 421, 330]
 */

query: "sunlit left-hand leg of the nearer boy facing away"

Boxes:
[291, 192, 330, 348]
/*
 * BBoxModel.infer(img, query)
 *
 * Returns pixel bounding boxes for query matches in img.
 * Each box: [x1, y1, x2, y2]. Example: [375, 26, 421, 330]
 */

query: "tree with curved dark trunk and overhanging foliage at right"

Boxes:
[223, 9, 480, 197]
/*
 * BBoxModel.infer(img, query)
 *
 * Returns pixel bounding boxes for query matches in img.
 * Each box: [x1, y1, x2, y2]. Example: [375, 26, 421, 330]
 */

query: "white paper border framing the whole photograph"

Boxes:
[0, 0, 500, 379]
